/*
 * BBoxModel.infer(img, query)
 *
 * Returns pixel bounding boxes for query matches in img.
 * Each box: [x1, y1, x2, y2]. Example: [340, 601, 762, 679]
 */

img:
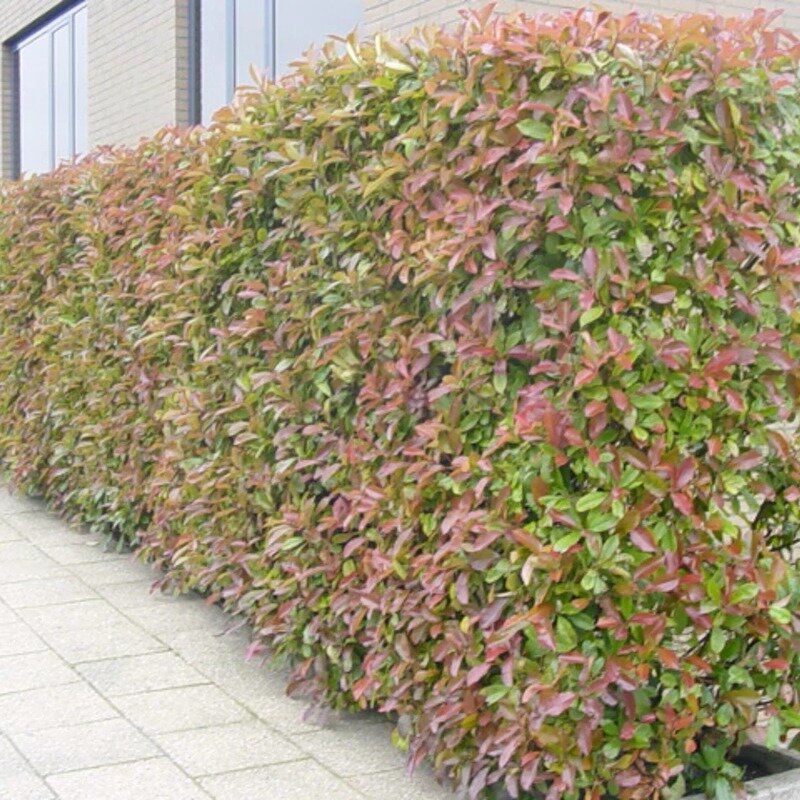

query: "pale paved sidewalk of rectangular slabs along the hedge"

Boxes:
[0, 487, 453, 800]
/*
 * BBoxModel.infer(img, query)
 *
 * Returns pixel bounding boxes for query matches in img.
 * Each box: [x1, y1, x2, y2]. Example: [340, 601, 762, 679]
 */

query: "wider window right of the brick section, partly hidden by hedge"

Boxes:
[193, 0, 363, 124]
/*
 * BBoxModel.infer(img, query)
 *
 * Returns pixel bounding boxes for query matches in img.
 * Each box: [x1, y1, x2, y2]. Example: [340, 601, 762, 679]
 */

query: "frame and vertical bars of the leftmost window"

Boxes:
[7, 0, 88, 177]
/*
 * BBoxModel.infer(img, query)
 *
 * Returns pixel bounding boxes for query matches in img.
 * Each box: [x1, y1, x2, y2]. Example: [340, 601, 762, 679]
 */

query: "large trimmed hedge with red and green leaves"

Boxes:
[0, 9, 800, 800]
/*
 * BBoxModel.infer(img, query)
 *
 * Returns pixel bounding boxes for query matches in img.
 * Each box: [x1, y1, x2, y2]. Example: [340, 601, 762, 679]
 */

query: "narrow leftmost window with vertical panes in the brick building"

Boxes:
[14, 4, 87, 174]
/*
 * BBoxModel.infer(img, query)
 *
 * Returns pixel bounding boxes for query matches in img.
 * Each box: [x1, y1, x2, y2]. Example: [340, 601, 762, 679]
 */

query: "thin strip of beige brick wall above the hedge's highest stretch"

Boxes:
[364, 0, 800, 34]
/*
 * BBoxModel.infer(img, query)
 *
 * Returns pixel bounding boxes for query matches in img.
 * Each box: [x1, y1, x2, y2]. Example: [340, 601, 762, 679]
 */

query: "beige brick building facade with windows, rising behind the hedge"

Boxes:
[0, 0, 800, 177]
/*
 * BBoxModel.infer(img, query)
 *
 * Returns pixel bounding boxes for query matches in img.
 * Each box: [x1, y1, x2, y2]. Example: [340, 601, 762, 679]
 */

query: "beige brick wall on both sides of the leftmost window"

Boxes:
[0, 0, 189, 176]
